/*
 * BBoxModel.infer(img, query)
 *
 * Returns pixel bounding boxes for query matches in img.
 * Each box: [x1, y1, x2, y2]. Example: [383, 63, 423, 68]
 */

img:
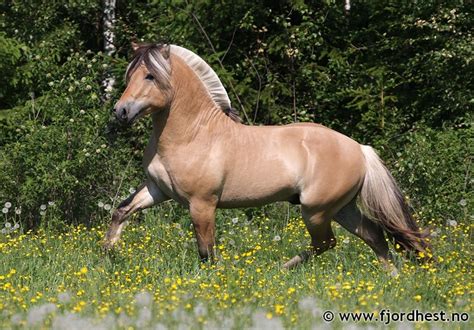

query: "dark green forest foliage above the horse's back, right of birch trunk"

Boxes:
[110, 1, 473, 141]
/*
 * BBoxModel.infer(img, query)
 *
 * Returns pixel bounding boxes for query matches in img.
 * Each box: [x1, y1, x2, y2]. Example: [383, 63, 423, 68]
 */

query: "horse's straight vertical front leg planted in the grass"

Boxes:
[189, 201, 216, 261]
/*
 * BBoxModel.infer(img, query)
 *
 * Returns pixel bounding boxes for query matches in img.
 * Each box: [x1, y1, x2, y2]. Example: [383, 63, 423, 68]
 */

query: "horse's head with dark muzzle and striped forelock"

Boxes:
[113, 43, 171, 124]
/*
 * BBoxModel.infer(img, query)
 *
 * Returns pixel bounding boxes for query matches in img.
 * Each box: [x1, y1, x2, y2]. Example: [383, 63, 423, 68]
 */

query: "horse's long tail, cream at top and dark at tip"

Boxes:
[360, 145, 429, 259]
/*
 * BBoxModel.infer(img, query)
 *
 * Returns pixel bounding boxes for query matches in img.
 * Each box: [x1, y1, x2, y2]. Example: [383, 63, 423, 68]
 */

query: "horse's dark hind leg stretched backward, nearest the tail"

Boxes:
[335, 199, 397, 274]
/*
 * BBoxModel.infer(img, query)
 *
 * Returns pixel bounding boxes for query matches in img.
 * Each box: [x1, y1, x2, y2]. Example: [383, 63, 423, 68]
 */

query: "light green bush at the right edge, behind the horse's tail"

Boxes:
[394, 127, 474, 223]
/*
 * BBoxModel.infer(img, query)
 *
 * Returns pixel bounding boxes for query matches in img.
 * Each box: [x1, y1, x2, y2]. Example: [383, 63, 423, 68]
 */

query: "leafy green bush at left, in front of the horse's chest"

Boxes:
[0, 52, 143, 227]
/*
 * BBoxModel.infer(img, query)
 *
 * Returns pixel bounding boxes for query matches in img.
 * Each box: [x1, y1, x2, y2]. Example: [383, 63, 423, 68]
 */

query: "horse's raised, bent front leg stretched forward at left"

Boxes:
[104, 180, 169, 249]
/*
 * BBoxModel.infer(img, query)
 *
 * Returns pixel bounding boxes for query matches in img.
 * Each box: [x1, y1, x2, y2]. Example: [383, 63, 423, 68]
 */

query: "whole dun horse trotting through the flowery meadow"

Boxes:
[105, 44, 428, 268]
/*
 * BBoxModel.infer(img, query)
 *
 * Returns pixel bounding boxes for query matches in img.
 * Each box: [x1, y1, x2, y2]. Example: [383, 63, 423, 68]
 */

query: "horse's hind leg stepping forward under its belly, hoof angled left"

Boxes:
[283, 206, 336, 269]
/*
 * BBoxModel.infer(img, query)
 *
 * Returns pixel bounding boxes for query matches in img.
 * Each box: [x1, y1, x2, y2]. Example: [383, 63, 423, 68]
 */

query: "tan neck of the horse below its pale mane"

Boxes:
[153, 59, 236, 150]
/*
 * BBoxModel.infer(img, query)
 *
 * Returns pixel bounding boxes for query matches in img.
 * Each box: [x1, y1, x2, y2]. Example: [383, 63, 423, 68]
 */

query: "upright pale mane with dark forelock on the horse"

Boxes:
[125, 43, 241, 122]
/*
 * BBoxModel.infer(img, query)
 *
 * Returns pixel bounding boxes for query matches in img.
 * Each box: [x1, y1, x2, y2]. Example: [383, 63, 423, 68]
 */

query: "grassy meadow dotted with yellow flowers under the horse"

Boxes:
[0, 204, 473, 330]
